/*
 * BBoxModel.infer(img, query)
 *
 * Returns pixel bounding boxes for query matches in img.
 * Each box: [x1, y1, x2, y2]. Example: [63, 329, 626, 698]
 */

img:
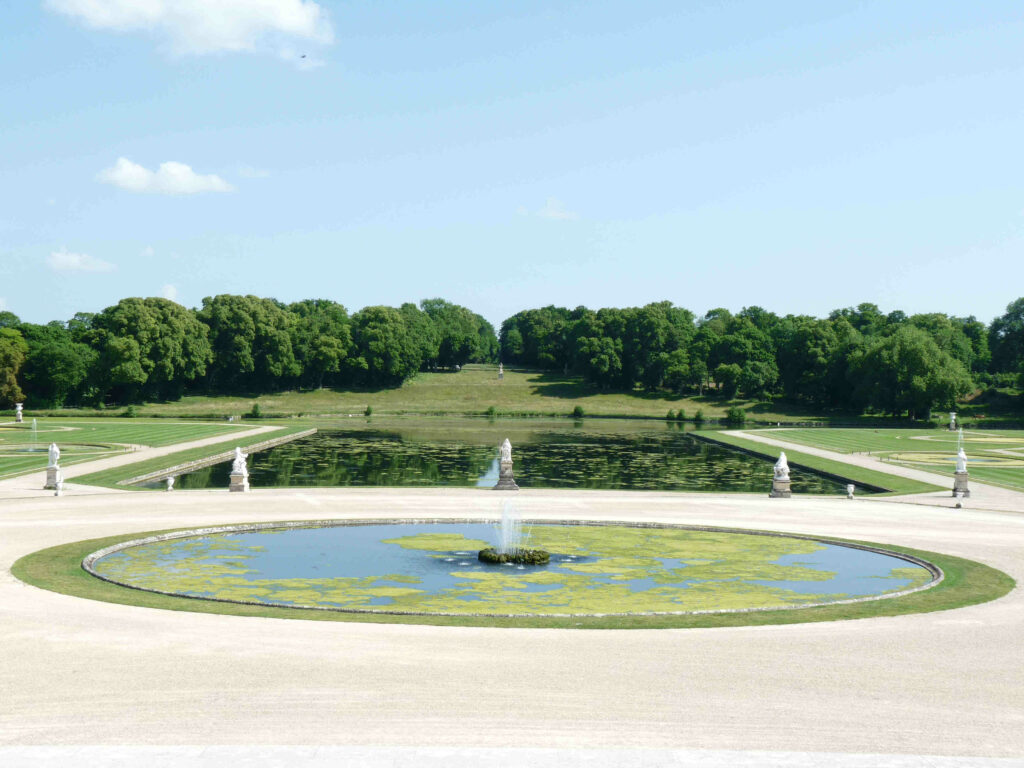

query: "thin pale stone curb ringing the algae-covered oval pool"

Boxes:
[82, 517, 945, 618]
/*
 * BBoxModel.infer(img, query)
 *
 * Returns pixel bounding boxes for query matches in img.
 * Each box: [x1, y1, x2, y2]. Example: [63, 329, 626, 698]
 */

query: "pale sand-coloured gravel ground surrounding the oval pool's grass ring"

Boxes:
[0, 489, 1024, 765]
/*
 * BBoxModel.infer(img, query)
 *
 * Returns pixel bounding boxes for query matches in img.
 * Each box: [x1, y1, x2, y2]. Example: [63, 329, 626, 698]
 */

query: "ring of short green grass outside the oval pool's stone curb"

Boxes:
[11, 530, 1015, 629]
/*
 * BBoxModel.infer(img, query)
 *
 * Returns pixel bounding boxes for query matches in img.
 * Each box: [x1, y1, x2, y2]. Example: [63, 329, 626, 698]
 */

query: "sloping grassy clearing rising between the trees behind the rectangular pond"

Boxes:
[18, 365, 929, 422]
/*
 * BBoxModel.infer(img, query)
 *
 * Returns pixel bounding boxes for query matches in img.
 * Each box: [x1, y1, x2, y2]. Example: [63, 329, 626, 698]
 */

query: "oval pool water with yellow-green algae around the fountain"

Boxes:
[84, 521, 937, 615]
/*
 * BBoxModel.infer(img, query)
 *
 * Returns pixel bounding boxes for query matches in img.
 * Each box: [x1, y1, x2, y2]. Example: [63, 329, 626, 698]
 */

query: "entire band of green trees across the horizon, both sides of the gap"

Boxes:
[0, 295, 1024, 418]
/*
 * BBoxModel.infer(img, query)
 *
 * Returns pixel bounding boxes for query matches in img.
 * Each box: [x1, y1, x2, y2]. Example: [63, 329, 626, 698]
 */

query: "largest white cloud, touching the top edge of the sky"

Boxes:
[46, 0, 334, 58]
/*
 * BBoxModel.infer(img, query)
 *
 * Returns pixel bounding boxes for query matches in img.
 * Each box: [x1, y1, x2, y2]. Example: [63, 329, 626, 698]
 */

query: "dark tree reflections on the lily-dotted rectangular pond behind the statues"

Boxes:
[178, 425, 844, 494]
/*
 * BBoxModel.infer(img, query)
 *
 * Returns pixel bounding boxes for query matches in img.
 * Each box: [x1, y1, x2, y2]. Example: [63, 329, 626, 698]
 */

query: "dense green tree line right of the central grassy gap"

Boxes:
[499, 298, 1024, 418]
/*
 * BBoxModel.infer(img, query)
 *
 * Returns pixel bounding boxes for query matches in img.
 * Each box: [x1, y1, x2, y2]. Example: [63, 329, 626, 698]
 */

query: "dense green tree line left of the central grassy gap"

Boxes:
[0, 295, 498, 408]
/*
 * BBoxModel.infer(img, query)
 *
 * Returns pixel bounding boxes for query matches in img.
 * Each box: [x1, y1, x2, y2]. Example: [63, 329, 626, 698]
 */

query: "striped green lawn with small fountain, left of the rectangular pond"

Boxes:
[0, 418, 248, 479]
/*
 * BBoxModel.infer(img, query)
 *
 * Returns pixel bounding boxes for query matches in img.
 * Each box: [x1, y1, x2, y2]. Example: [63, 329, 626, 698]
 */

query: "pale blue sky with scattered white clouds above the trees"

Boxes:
[0, 0, 1024, 325]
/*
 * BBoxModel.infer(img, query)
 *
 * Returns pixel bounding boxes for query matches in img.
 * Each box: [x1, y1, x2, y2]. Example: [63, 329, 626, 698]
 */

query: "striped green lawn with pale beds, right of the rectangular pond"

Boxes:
[765, 429, 1024, 490]
